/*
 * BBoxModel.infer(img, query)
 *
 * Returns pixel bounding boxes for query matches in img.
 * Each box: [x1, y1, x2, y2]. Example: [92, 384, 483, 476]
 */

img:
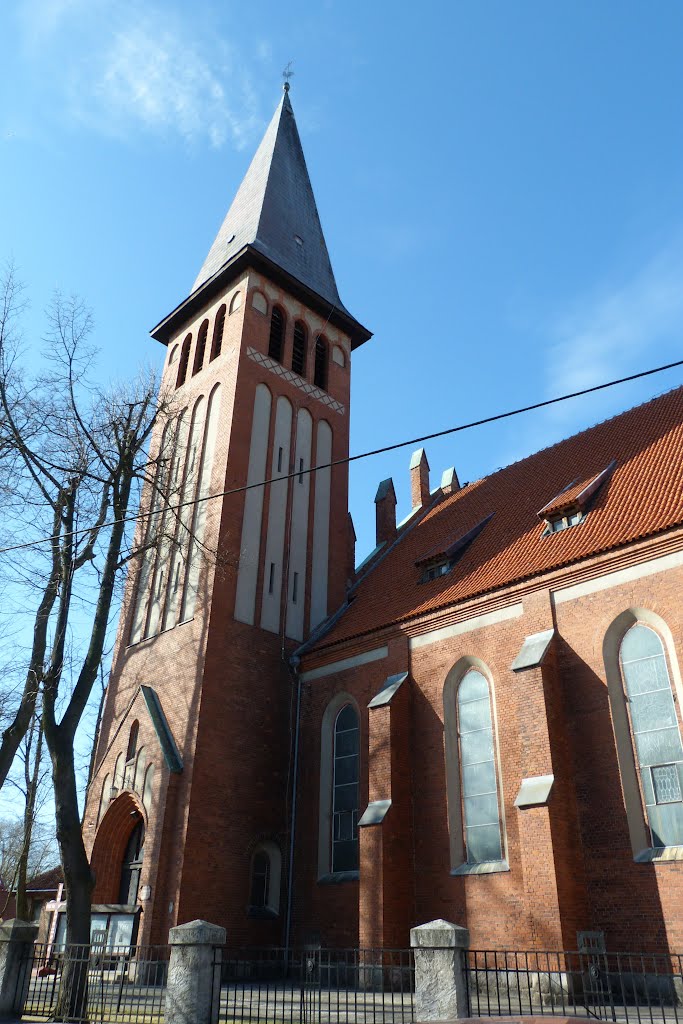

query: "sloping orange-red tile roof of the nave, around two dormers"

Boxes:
[315, 387, 683, 649]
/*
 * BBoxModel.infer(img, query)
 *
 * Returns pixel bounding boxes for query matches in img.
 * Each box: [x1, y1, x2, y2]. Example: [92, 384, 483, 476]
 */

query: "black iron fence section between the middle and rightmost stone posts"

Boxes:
[214, 947, 415, 1024]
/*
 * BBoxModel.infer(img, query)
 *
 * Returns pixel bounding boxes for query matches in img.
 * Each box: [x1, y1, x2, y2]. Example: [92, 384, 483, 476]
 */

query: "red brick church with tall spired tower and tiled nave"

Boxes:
[84, 89, 683, 951]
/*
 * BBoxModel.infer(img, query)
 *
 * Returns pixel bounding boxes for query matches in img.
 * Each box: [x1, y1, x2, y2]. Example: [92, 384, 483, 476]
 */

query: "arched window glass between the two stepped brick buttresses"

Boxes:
[458, 669, 503, 864]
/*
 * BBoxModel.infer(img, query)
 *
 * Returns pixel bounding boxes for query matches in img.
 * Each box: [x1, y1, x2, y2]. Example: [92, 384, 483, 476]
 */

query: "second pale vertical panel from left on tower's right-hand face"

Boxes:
[261, 396, 292, 633]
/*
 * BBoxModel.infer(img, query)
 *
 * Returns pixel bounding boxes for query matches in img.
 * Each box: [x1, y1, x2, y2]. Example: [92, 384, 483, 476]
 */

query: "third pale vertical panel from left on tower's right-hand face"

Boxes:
[286, 409, 313, 640]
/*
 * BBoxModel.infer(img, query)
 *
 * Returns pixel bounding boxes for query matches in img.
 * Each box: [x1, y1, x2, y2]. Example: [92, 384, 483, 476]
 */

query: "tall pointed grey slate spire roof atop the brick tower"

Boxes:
[193, 91, 346, 312]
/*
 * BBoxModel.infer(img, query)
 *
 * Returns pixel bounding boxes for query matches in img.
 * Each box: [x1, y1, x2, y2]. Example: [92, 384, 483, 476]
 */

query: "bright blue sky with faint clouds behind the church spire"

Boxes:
[0, 0, 683, 618]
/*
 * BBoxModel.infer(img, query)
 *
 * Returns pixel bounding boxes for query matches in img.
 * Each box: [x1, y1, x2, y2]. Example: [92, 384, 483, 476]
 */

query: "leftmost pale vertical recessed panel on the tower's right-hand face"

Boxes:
[234, 384, 271, 626]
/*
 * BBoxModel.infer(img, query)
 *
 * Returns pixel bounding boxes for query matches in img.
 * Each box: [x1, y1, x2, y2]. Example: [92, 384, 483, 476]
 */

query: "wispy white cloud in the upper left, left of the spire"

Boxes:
[22, 0, 259, 148]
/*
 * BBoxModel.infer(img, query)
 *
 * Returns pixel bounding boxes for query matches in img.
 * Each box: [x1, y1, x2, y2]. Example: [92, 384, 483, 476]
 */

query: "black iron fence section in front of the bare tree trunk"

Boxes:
[17, 943, 169, 1024]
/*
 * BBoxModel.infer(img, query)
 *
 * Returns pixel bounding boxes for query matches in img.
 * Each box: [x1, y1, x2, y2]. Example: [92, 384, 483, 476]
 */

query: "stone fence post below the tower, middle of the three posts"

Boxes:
[165, 921, 225, 1024]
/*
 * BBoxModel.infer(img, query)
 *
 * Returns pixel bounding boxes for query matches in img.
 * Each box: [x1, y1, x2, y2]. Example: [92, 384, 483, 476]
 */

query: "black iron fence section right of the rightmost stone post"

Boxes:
[467, 949, 683, 1024]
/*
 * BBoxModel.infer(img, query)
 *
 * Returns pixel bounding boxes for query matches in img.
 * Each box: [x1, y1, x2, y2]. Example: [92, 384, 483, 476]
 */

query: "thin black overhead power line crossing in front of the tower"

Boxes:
[0, 359, 683, 555]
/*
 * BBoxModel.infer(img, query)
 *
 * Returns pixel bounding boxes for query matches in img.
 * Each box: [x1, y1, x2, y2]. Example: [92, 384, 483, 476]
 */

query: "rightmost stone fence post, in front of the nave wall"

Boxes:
[411, 921, 470, 1021]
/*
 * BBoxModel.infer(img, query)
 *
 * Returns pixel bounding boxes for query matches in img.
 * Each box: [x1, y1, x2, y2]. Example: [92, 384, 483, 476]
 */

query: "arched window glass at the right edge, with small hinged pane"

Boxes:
[620, 623, 683, 849]
